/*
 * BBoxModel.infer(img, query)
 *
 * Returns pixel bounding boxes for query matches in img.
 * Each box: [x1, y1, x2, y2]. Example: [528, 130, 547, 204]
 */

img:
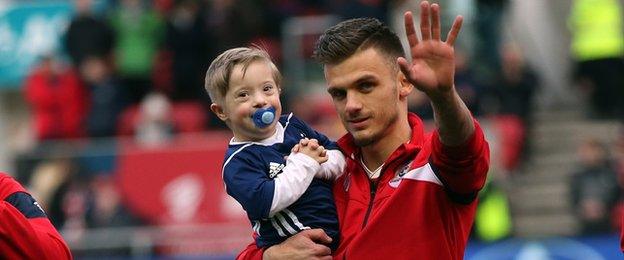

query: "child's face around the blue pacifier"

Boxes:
[219, 61, 282, 141]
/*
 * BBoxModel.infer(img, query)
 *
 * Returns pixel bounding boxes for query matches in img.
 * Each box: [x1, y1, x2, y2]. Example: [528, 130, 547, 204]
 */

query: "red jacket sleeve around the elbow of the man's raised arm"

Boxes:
[430, 120, 490, 204]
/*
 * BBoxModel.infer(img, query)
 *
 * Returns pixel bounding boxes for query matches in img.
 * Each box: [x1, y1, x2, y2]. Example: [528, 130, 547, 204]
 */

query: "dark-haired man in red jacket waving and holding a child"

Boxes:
[238, 1, 489, 259]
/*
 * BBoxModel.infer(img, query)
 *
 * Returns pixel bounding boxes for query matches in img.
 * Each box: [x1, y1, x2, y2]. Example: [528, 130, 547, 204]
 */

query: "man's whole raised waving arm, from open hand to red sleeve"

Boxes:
[398, 1, 489, 198]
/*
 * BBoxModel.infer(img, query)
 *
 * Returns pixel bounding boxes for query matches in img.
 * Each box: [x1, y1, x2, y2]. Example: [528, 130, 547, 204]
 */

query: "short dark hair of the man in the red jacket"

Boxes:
[313, 18, 405, 64]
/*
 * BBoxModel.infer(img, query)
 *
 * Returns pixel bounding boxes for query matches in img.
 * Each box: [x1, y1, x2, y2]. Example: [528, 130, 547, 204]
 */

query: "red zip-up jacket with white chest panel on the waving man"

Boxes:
[238, 114, 489, 260]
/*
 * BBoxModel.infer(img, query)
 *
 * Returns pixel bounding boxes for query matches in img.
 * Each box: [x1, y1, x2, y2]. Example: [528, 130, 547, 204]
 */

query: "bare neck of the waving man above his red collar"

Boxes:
[361, 116, 412, 169]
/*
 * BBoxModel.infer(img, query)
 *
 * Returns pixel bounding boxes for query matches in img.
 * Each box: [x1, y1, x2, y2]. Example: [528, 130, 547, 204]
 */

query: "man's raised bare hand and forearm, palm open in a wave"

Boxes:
[398, 1, 474, 146]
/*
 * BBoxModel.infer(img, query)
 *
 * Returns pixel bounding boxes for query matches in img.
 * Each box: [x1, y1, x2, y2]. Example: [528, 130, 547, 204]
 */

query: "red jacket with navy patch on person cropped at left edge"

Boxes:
[0, 173, 72, 259]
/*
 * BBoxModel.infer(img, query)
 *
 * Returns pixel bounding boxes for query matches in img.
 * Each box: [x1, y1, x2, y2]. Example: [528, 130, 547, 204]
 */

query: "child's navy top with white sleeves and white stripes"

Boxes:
[223, 114, 344, 250]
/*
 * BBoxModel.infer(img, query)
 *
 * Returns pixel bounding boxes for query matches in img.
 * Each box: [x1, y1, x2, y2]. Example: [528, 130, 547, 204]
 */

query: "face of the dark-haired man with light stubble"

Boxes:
[325, 48, 411, 146]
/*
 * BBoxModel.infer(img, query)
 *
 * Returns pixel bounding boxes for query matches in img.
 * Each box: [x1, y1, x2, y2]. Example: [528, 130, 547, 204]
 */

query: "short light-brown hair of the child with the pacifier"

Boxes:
[205, 46, 282, 103]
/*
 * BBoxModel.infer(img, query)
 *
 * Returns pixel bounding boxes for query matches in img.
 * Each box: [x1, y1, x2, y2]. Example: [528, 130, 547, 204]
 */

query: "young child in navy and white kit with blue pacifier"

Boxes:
[206, 48, 345, 250]
